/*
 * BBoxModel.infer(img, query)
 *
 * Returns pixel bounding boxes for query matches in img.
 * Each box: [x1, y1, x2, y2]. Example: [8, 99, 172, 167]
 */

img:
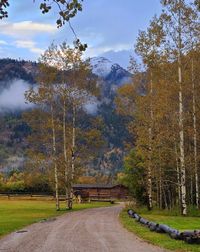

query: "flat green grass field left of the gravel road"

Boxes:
[0, 198, 110, 237]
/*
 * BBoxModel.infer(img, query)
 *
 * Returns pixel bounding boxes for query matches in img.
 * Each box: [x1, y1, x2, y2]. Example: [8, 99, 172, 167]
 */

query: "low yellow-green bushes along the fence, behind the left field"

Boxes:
[0, 169, 114, 196]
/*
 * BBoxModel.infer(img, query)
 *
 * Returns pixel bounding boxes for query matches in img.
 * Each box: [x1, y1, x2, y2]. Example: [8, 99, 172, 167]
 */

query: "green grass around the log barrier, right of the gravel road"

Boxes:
[120, 207, 200, 252]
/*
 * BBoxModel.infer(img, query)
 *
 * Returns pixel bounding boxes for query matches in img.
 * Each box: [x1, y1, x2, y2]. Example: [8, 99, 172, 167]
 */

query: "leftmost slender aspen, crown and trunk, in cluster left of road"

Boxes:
[25, 47, 60, 210]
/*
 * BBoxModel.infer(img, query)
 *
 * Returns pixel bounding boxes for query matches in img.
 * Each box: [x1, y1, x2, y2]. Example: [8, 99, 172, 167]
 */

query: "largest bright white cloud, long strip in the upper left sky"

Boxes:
[0, 21, 57, 37]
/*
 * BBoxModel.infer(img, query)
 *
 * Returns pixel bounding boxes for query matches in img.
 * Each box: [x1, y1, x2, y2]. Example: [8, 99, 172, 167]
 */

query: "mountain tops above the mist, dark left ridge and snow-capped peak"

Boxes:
[0, 57, 132, 101]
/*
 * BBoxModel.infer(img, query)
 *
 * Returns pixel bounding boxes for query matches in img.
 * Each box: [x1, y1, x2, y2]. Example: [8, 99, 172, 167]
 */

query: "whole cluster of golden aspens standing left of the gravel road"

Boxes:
[24, 43, 104, 210]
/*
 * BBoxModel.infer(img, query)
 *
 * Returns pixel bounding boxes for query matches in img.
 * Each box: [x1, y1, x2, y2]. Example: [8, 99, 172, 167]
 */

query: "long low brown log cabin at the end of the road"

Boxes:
[73, 184, 128, 199]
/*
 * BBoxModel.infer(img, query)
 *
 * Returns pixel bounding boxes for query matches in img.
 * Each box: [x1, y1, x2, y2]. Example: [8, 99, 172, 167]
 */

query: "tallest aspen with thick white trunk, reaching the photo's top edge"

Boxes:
[161, 0, 198, 215]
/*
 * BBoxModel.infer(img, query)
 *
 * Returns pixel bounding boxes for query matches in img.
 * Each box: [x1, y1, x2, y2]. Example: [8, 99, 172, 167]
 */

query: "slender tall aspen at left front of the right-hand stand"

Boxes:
[136, 17, 164, 209]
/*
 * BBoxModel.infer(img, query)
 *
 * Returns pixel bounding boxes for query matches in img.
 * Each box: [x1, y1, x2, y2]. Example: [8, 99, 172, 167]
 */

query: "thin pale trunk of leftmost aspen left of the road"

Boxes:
[51, 104, 60, 211]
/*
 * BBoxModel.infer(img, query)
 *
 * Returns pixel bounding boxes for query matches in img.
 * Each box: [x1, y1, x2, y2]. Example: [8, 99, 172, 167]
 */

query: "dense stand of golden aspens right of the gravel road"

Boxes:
[116, 0, 200, 215]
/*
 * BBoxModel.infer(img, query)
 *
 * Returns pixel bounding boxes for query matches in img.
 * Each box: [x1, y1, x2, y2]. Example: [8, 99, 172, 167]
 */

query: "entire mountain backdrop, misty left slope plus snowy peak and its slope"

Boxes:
[0, 57, 132, 175]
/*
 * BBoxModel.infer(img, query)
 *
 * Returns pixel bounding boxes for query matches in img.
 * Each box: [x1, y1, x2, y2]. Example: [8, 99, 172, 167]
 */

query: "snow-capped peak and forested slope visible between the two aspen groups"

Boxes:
[90, 57, 132, 176]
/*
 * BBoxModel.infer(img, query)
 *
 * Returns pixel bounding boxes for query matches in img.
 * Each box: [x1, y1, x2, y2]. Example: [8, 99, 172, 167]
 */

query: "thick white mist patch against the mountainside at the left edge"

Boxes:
[0, 80, 32, 112]
